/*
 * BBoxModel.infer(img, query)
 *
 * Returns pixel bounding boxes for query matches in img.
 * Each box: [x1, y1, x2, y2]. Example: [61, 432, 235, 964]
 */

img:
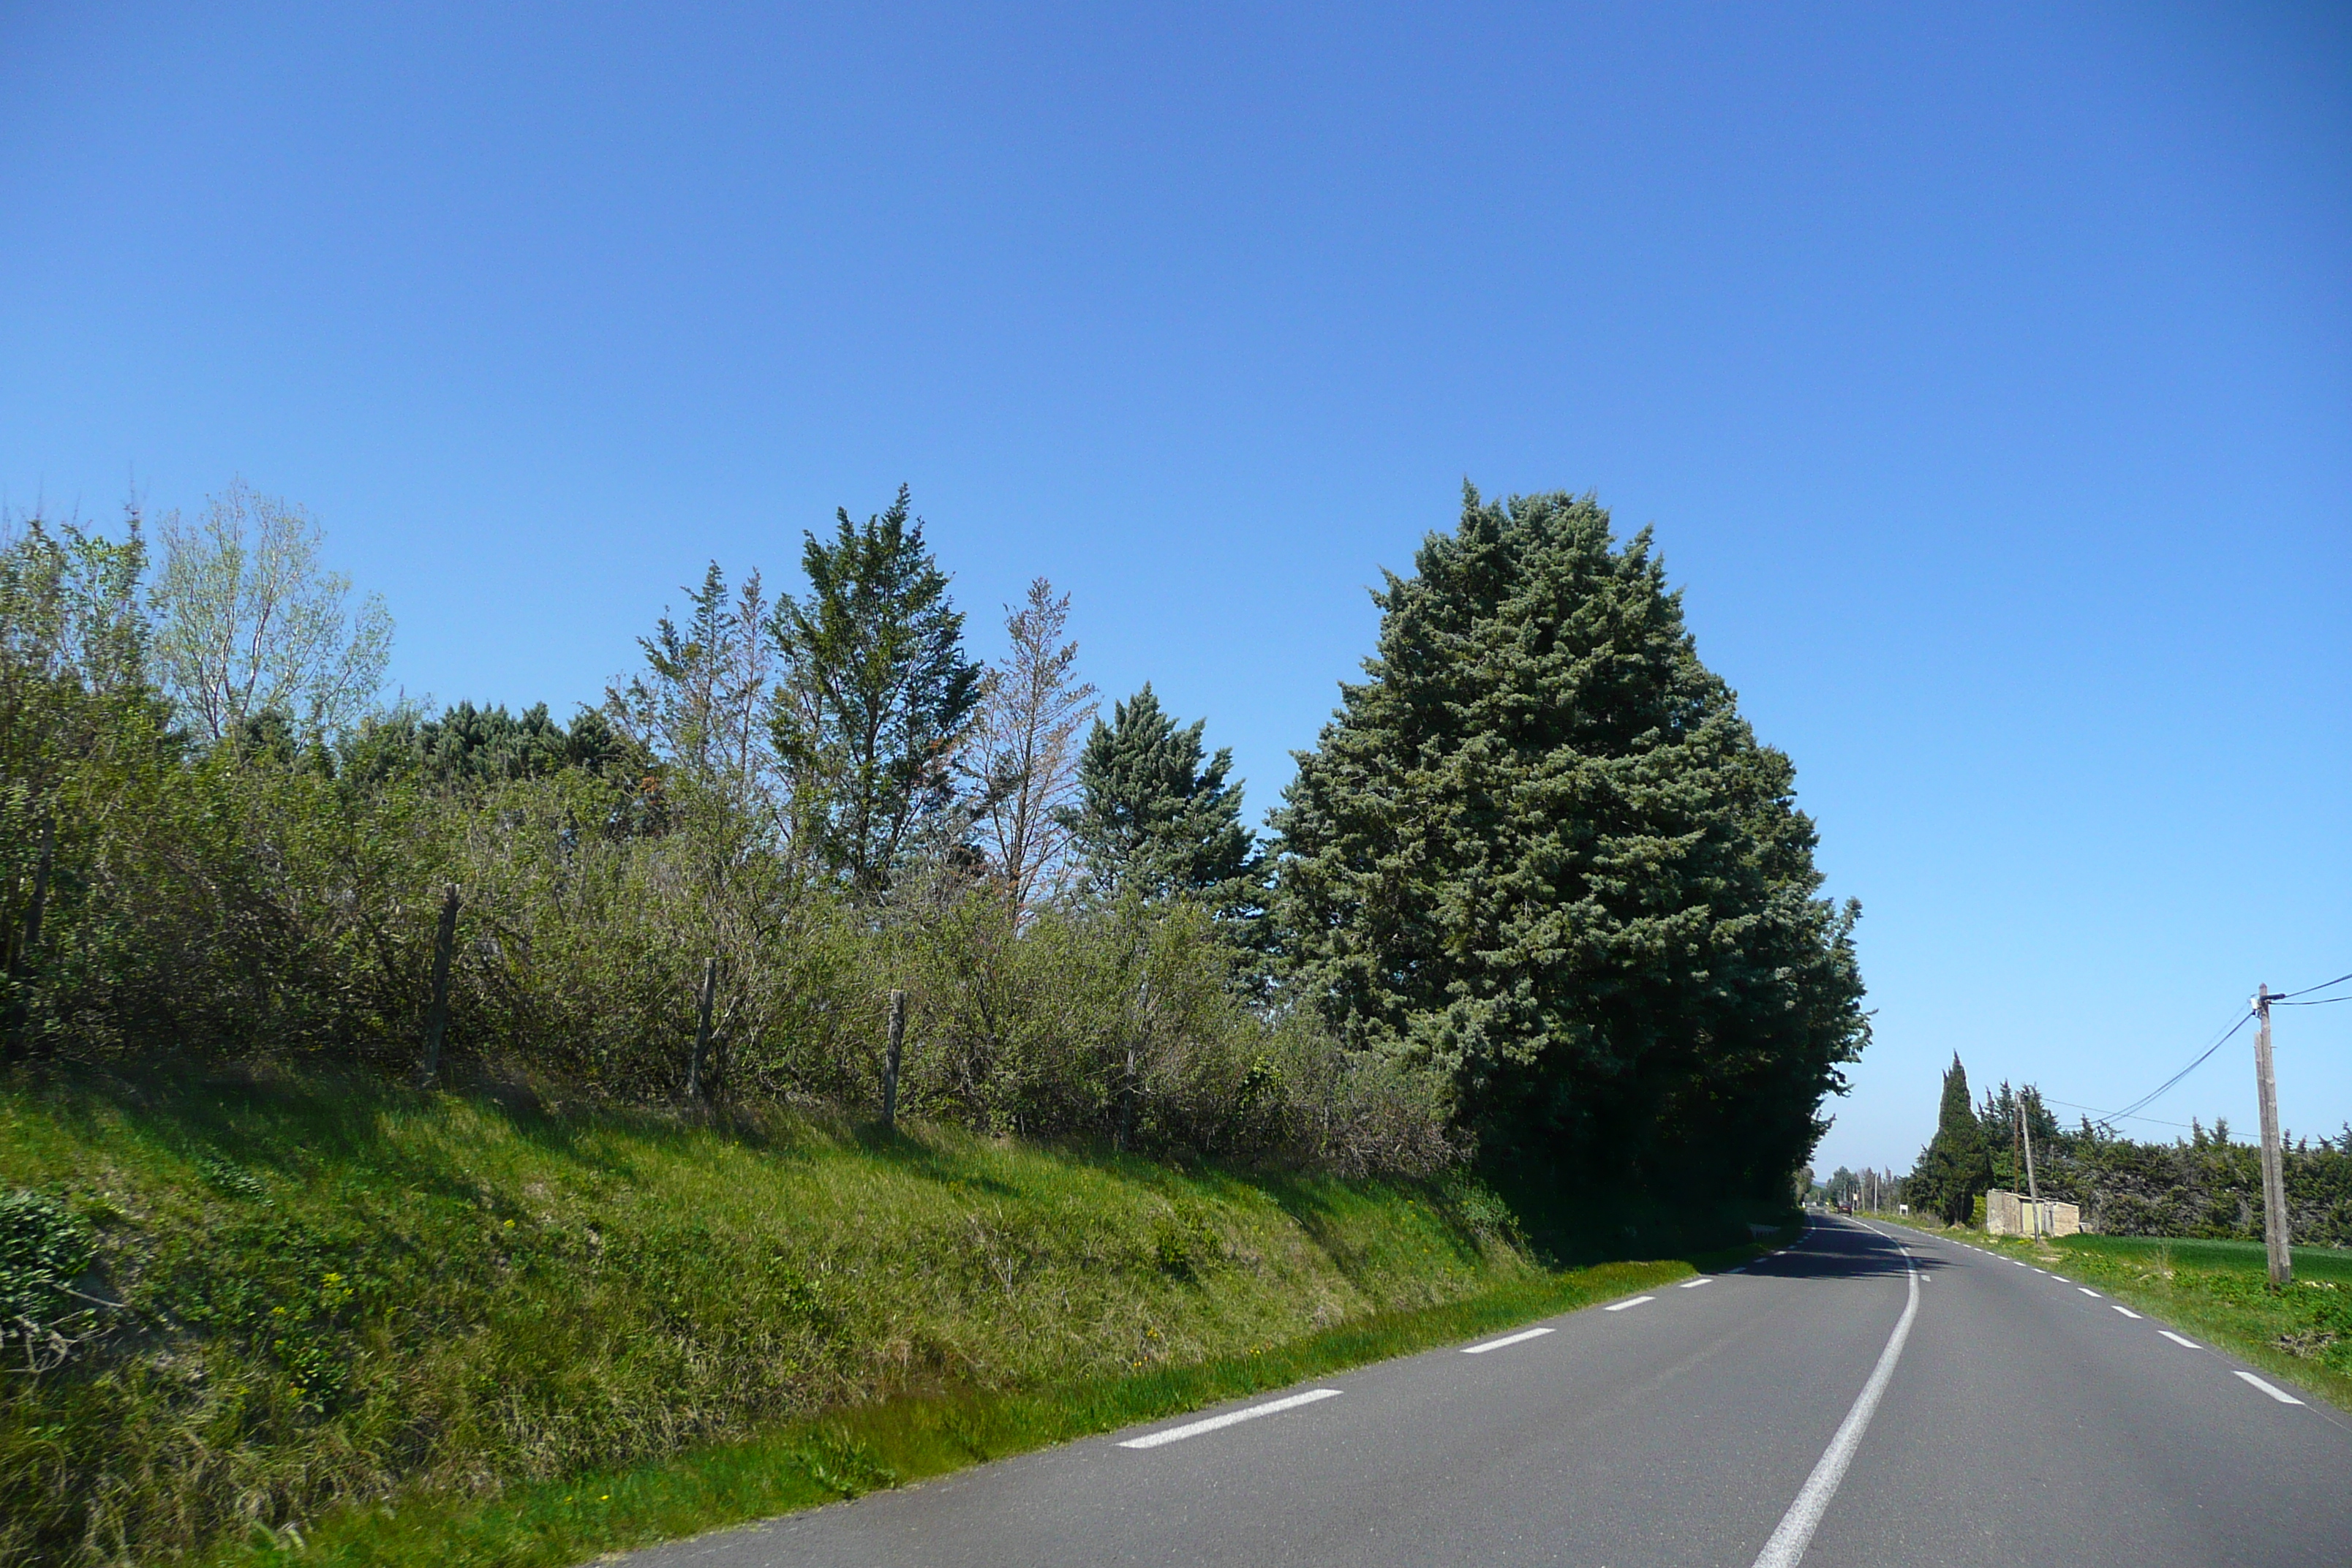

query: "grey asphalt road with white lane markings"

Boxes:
[625, 1218, 2352, 1568]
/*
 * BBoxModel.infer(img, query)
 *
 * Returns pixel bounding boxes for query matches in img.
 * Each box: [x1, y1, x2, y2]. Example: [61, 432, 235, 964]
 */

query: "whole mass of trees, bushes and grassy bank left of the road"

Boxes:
[0, 484, 1868, 1564]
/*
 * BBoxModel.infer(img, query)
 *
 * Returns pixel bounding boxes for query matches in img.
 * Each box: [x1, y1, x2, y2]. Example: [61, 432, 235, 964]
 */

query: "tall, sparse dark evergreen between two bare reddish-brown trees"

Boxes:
[769, 484, 981, 896]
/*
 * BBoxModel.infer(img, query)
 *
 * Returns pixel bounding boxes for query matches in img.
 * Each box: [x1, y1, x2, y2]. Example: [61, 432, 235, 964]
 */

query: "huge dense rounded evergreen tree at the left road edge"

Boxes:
[1275, 486, 1868, 1196]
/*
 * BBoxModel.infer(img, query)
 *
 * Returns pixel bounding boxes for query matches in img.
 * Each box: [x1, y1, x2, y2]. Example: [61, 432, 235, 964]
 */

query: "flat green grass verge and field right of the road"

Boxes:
[1868, 1215, 2352, 1411]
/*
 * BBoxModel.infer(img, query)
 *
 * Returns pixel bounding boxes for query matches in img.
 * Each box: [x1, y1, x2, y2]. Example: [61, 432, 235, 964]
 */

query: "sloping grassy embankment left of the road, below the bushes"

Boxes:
[0, 1079, 1778, 1568]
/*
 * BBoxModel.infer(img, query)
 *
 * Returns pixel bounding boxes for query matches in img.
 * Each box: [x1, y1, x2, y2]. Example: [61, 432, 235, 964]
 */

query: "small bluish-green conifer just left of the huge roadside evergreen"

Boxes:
[1060, 682, 1263, 914]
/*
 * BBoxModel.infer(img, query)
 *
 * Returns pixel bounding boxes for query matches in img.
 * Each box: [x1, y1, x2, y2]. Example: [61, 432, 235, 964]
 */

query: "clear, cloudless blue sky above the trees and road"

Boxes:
[0, 4, 2352, 1169]
